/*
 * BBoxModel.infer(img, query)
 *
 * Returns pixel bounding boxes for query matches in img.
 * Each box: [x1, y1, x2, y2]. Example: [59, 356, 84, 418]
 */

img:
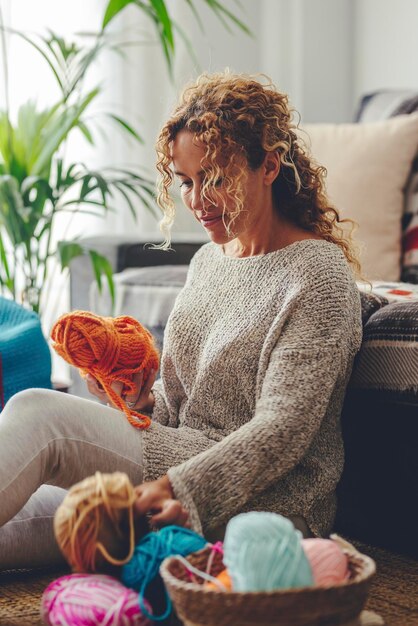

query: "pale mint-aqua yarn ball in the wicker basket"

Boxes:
[223, 511, 314, 592]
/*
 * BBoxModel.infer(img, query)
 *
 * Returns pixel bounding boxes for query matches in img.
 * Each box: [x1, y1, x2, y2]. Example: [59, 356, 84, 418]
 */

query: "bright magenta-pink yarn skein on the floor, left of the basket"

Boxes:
[41, 574, 151, 626]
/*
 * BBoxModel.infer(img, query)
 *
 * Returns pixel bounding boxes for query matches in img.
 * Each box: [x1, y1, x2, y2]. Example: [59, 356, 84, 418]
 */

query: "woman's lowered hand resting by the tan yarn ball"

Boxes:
[134, 476, 189, 528]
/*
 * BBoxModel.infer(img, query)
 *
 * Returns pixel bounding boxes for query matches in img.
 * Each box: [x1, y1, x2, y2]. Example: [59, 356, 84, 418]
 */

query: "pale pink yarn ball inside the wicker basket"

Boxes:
[302, 538, 349, 587]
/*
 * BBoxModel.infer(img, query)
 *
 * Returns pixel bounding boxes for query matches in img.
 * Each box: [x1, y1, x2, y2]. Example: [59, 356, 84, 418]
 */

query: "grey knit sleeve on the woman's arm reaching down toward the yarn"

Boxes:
[168, 268, 360, 532]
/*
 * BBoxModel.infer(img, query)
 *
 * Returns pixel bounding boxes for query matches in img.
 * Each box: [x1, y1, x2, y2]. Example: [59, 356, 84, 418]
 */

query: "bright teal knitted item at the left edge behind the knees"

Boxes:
[0, 296, 51, 411]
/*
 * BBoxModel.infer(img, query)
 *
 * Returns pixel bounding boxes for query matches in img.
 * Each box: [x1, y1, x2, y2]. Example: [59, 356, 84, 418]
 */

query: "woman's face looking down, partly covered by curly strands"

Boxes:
[171, 130, 272, 244]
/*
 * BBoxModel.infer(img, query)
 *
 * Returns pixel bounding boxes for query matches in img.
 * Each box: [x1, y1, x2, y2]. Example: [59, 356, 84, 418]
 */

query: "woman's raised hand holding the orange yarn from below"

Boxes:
[86, 370, 157, 413]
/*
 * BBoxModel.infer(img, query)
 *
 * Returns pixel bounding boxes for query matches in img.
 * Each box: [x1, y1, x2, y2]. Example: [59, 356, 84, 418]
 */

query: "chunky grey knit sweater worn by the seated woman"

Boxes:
[143, 240, 362, 535]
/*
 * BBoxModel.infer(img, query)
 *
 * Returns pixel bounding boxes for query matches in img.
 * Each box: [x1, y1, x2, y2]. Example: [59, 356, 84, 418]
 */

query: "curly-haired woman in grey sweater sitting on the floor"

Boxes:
[0, 73, 362, 568]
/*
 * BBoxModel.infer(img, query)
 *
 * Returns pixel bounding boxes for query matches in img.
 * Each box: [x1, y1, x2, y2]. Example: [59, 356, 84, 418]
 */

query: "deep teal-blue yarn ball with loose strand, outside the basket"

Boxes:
[121, 526, 207, 621]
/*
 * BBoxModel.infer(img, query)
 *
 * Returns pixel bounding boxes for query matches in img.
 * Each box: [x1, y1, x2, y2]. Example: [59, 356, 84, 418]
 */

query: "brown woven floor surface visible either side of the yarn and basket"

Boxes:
[0, 541, 418, 626]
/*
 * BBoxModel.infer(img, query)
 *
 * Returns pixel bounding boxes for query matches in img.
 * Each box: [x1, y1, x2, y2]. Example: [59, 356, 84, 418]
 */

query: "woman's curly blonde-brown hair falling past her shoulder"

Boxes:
[156, 70, 360, 274]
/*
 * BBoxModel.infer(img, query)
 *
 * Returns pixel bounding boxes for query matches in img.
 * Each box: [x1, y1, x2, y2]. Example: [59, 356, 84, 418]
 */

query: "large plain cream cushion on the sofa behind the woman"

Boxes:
[300, 114, 418, 280]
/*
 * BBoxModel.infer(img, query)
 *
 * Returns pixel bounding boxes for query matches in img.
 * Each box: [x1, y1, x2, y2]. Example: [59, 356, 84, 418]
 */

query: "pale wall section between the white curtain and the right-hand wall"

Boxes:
[259, 0, 354, 122]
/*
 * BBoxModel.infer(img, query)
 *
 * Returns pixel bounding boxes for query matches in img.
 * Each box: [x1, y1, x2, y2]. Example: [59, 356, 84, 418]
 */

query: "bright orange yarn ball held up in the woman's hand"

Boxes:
[51, 311, 159, 428]
